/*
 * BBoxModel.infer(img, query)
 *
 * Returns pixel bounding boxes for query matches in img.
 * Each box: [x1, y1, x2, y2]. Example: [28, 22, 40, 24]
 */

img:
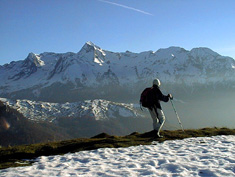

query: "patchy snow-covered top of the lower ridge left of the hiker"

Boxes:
[0, 98, 144, 122]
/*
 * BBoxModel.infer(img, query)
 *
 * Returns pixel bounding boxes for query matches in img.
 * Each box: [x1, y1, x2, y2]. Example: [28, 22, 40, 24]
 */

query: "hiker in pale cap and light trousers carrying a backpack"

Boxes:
[140, 79, 173, 138]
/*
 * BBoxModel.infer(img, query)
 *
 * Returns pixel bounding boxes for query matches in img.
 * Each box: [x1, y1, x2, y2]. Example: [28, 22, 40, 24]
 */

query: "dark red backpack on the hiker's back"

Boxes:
[140, 87, 154, 108]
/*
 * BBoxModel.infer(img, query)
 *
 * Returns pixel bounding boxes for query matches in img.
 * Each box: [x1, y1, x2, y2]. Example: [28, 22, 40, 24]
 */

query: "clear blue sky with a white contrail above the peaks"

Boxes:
[0, 0, 235, 65]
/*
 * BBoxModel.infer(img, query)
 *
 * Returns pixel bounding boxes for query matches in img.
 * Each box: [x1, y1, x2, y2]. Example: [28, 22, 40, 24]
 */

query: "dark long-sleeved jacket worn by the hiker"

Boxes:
[151, 85, 169, 109]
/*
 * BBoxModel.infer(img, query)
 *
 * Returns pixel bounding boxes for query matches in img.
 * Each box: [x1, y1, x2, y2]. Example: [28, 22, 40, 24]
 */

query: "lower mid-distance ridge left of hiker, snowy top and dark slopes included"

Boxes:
[0, 98, 152, 146]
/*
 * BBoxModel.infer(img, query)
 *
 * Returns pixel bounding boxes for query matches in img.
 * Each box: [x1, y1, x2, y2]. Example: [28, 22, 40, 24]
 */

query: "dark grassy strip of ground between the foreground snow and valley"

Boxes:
[0, 127, 235, 169]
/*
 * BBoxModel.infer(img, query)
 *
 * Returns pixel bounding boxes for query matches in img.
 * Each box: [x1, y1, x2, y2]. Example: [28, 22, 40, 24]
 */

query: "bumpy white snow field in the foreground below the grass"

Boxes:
[0, 135, 235, 177]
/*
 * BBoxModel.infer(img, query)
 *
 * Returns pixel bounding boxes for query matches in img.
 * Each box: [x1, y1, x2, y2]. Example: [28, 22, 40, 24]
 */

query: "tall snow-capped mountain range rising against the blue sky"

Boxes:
[0, 42, 235, 102]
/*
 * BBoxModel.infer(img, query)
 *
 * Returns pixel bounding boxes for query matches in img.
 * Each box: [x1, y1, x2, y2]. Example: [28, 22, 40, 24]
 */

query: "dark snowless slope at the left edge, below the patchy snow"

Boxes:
[0, 101, 70, 146]
